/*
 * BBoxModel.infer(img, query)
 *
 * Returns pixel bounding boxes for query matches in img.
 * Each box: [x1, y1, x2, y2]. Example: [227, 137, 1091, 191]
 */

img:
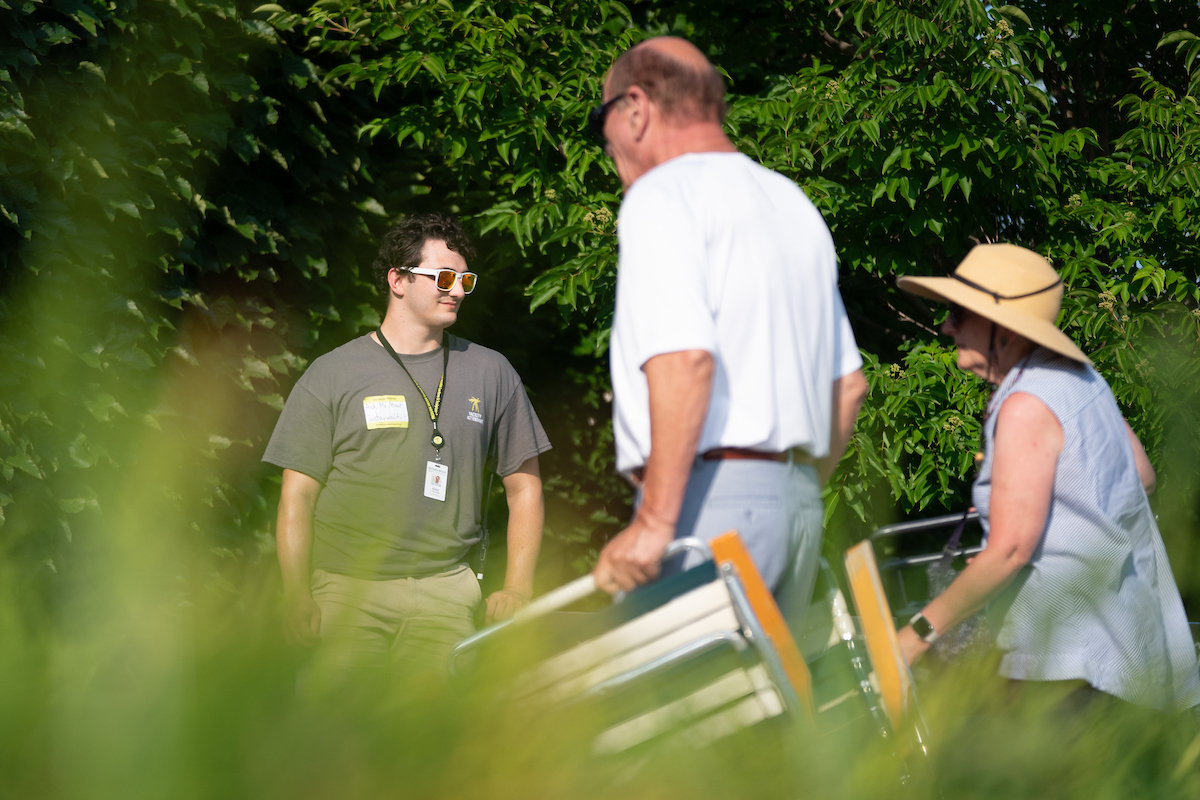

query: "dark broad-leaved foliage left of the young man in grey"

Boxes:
[0, 2, 407, 599]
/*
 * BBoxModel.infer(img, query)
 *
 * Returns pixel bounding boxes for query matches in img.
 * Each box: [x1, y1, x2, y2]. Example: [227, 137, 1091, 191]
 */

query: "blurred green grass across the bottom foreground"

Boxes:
[0, 519, 1200, 800]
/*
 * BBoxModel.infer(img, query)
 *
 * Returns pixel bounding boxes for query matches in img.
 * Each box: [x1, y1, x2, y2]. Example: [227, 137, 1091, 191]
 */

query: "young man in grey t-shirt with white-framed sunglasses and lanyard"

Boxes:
[263, 215, 550, 682]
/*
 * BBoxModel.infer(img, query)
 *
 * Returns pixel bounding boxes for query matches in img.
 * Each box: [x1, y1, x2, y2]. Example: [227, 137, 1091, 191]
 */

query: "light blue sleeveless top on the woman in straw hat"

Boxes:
[972, 348, 1200, 710]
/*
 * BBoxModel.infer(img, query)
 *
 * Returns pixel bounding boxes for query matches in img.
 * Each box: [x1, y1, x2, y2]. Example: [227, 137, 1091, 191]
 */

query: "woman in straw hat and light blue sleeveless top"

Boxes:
[899, 245, 1200, 710]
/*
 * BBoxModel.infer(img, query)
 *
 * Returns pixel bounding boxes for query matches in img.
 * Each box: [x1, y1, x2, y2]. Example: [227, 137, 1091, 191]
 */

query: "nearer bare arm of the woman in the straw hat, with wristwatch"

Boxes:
[900, 392, 1063, 664]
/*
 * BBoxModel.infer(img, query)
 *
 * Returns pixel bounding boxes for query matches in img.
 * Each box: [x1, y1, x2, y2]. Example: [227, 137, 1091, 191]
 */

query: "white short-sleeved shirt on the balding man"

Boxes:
[611, 152, 863, 471]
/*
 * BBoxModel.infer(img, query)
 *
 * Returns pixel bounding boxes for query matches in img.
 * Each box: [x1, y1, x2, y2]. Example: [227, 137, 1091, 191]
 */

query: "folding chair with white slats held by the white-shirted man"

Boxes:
[450, 533, 811, 756]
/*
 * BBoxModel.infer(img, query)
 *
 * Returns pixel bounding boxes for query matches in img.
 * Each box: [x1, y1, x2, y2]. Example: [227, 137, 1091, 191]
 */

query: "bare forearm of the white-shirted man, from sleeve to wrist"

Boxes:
[638, 350, 714, 525]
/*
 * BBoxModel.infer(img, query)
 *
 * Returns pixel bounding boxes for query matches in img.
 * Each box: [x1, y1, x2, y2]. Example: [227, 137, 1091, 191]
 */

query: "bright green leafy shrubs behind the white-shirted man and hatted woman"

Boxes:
[288, 0, 1200, 587]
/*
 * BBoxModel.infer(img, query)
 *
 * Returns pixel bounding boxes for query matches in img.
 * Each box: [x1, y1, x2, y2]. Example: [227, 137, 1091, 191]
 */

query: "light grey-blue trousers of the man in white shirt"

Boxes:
[652, 458, 824, 640]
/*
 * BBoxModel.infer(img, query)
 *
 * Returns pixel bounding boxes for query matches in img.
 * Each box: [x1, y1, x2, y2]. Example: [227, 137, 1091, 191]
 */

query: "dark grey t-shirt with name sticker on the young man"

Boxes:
[263, 335, 550, 581]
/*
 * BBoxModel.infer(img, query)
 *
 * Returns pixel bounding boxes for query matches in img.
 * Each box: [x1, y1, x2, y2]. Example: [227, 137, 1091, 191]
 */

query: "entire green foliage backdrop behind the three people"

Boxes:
[0, 0, 1200, 597]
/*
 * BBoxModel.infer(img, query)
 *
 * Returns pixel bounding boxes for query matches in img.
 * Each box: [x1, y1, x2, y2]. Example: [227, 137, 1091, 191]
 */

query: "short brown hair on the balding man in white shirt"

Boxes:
[608, 47, 725, 124]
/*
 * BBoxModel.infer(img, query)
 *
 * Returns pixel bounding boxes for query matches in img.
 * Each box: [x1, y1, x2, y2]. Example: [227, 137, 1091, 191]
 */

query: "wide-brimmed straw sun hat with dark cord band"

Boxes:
[896, 245, 1091, 363]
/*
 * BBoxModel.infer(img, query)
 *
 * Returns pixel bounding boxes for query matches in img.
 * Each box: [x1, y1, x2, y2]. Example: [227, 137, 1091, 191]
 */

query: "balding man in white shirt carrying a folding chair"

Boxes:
[589, 37, 866, 628]
